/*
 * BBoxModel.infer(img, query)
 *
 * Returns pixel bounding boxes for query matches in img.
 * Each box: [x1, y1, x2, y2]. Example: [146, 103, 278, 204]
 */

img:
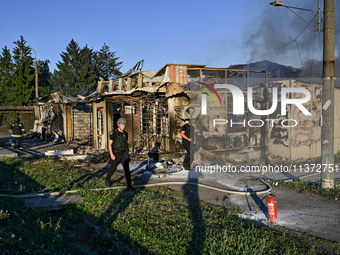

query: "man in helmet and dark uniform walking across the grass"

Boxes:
[105, 118, 134, 190]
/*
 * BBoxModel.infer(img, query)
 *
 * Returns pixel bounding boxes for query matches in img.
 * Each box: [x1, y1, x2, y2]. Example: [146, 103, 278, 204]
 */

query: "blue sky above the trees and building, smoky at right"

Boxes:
[0, 0, 340, 72]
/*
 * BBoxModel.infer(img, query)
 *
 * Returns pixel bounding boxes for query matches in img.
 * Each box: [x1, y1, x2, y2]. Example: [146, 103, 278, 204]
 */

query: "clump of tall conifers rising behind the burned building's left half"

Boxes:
[51, 39, 123, 96]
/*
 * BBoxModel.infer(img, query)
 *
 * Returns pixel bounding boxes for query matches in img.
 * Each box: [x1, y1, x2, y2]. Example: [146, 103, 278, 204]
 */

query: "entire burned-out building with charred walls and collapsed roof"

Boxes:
[35, 64, 340, 162]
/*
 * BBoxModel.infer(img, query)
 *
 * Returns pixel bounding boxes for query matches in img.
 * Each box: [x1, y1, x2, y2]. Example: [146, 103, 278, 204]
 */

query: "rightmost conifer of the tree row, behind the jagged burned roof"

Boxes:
[95, 43, 123, 81]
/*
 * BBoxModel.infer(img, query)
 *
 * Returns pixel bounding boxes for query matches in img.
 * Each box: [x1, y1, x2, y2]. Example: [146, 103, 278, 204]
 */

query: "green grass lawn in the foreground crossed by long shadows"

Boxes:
[0, 158, 340, 254]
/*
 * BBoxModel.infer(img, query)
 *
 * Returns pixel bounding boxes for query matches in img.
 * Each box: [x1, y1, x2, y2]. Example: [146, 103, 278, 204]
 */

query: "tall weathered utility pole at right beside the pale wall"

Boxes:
[321, 0, 335, 189]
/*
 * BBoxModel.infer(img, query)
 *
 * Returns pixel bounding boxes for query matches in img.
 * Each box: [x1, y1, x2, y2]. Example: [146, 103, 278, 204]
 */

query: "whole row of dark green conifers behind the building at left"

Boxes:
[0, 36, 123, 106]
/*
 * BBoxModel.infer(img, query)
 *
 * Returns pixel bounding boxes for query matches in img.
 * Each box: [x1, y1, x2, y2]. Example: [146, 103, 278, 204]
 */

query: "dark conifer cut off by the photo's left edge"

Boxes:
[0, 46, 13, 105]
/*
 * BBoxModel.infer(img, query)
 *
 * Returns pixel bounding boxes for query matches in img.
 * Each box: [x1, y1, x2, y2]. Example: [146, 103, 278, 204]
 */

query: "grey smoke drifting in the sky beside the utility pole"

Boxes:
[246, 0, 340, 83]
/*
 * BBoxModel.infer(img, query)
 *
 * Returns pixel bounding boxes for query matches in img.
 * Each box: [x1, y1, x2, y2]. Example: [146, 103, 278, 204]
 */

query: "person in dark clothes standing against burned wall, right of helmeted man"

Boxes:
[181, 119, 196, 170]
